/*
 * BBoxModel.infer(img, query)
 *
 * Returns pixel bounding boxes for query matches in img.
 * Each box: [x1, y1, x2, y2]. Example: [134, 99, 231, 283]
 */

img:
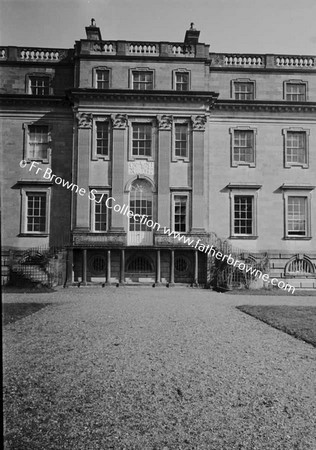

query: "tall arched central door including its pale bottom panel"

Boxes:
[128, 179, 153, 245]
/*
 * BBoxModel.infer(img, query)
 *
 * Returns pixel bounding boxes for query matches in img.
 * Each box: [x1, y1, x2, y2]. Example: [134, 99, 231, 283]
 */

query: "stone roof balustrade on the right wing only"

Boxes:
[210, 53, 316, 69]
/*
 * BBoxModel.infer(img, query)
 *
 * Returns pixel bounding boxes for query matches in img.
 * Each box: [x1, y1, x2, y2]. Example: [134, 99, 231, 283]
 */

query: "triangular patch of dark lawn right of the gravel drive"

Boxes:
[237, 305, 316, 347]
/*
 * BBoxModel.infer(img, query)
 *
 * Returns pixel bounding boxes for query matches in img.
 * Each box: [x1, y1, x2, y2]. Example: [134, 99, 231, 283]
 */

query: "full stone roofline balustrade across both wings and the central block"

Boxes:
[0, 44, 316, 70]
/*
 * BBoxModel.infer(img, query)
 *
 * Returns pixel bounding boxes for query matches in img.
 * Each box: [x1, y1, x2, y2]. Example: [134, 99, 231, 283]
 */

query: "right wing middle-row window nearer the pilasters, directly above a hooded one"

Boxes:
[230, 129, 255, 167]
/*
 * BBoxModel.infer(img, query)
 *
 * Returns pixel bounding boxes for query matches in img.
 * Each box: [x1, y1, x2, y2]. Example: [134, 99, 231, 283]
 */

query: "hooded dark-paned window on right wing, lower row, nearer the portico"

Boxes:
[226, 183, 262, 239]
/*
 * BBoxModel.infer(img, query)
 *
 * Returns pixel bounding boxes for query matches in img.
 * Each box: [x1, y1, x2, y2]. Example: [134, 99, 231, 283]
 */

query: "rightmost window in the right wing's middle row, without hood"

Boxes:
[283, 128, 309, 168]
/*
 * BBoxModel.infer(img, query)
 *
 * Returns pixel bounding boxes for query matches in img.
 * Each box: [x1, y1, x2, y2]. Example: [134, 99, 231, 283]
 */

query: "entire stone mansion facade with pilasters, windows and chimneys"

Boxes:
[0, 20, 316, 287]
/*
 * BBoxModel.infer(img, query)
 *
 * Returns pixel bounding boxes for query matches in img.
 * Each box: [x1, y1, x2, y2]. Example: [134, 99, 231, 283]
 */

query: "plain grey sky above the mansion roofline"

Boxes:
[0, 0, 316, 55]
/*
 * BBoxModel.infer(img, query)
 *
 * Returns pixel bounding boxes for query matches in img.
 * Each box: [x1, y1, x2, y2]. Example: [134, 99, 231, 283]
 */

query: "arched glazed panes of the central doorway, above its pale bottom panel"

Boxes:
[129, 179, 153, 231]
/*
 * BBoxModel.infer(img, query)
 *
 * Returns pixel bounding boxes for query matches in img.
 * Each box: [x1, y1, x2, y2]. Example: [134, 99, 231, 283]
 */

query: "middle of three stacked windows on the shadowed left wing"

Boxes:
[26, 125, 50, 161]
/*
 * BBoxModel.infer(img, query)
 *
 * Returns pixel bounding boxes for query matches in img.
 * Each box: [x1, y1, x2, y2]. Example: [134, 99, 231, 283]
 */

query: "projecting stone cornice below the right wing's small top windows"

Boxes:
[214, 100, 316, 113]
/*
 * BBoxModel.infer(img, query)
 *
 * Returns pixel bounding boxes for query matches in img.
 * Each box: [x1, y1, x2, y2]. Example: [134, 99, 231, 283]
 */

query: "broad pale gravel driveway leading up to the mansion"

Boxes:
[4, 287, 316, 450]
